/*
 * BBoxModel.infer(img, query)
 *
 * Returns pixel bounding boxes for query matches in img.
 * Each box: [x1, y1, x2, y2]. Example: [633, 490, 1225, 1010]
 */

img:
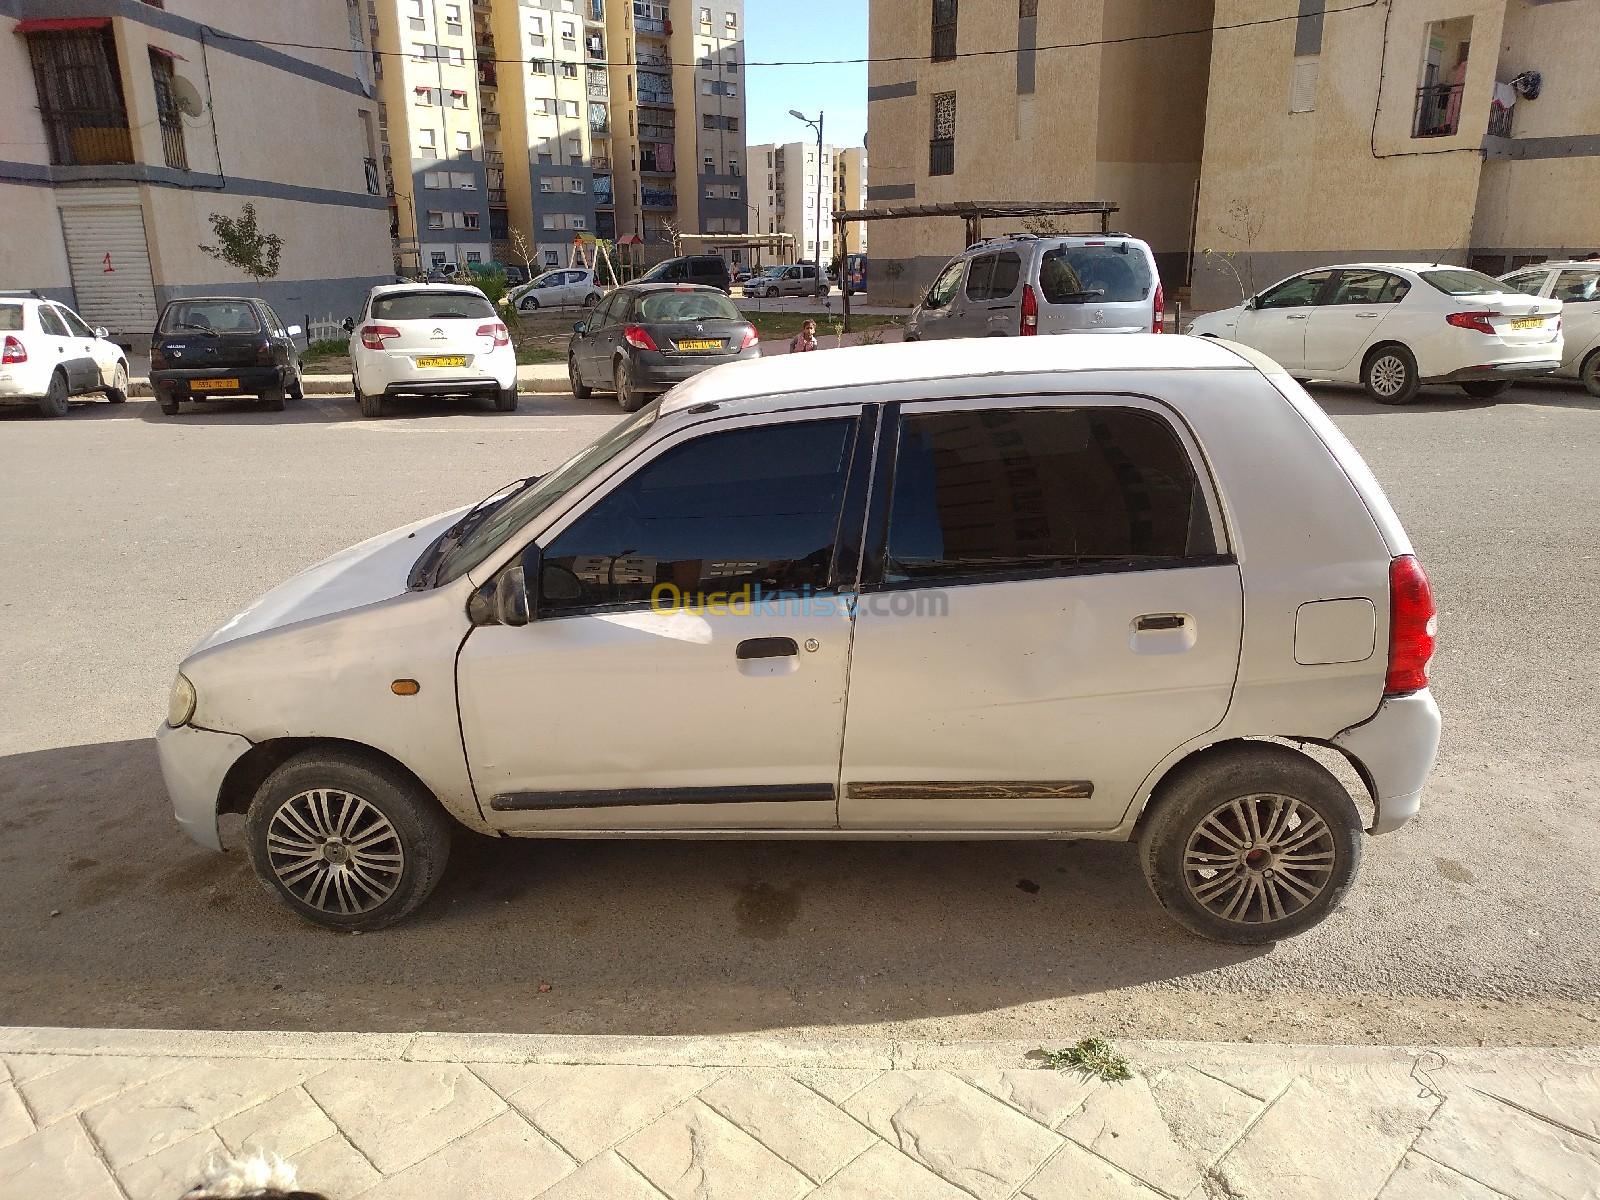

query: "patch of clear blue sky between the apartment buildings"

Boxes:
[744, 0, 867, 146]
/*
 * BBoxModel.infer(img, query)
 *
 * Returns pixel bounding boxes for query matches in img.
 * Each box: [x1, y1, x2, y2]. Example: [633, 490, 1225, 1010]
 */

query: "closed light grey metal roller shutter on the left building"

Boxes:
[56, 189, 155, 336]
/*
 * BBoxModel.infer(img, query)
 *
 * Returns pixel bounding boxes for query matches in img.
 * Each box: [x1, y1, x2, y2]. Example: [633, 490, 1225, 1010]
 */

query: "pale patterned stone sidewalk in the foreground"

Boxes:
[0, 1029, 1600, 1200]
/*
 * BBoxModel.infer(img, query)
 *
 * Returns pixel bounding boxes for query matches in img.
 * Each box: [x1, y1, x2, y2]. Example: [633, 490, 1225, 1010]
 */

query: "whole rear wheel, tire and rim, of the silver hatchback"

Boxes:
[1139, 742, 1362, 946]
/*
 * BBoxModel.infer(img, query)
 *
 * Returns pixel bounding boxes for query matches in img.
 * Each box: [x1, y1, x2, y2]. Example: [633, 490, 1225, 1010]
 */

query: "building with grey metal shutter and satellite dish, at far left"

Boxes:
[0, 0, 390, 342]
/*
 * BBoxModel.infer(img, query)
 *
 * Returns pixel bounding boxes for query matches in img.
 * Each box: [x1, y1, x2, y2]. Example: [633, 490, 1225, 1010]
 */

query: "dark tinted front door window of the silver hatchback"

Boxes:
[539, 419, 856, 616]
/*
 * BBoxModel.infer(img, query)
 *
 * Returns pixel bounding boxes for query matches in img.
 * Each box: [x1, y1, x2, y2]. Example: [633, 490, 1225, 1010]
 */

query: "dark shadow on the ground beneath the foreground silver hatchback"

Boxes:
[0, 739, 1267, 1034]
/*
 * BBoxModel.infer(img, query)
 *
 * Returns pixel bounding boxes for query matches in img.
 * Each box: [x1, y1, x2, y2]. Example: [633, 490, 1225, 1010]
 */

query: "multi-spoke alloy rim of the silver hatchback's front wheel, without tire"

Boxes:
[267, 787, 405, 917]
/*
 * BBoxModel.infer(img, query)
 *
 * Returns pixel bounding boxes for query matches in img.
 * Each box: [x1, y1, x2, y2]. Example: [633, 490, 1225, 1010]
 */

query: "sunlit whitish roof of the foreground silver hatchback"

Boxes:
[661, 333, 1248, 413]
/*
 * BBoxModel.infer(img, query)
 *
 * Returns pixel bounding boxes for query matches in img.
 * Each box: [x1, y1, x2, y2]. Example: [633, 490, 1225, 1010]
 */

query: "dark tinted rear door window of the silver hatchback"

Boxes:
[883, 408, 1216, 582]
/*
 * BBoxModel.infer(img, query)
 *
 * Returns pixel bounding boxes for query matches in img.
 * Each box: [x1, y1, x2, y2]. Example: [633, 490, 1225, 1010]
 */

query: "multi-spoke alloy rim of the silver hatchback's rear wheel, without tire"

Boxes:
[1184, 792, 1338, 925]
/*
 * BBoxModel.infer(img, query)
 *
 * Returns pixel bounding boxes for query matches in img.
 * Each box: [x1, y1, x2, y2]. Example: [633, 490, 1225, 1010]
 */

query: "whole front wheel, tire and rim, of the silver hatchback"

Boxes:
[245, 750, 450, 933]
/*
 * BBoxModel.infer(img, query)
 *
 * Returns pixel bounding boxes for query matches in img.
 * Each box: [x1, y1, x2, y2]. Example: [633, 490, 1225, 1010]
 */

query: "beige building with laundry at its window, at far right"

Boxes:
[1194, 0, 1600, 307]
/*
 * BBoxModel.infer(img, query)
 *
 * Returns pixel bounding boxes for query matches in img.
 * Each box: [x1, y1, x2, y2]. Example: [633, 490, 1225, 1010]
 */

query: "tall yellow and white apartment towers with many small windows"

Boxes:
[370, 0, 746, 269]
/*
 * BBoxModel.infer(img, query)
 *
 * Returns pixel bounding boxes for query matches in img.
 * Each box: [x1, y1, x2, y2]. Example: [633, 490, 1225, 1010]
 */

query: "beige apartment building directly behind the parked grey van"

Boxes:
[867, 0, 1209, 301]
